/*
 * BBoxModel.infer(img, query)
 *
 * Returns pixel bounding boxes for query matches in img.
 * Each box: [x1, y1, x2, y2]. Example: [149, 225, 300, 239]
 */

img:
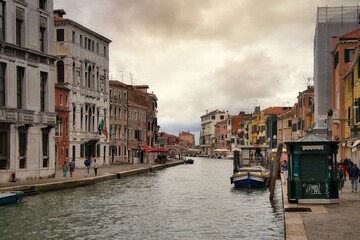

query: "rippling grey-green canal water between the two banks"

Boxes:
[0, 158, 285, 240]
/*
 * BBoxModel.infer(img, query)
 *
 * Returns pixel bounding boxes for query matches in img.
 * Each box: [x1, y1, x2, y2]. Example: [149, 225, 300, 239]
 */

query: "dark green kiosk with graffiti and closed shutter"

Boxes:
[285, 133, 339, 204]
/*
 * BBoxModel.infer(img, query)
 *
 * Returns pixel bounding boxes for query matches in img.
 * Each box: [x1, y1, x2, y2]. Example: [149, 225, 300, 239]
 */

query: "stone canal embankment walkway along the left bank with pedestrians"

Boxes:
[0, 161, 183, 195]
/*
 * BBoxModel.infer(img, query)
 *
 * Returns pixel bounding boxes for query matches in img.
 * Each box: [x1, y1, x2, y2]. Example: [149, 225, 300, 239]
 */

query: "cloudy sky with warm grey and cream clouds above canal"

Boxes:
[54, 0, 358, 140]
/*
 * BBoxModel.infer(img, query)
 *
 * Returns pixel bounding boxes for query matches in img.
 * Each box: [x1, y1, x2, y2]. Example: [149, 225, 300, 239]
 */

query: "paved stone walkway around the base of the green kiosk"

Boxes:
[282, 175, 360, 240]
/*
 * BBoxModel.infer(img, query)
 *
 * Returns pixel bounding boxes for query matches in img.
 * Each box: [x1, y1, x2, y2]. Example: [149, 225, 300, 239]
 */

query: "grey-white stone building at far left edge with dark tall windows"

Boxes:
[0, 0, 56, 182]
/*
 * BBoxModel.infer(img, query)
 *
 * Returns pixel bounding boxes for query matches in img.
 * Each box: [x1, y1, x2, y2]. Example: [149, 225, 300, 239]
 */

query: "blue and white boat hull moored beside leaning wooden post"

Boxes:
[230, 166, 270, 188]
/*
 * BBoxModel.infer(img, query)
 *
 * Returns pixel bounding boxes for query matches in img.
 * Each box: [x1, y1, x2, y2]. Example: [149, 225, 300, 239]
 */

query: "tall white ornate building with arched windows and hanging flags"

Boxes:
[54, 10, 111, 167]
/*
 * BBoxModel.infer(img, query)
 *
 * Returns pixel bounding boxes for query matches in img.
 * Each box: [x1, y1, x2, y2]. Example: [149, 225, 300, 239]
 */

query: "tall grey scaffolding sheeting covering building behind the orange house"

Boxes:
[314, 6, 360, 139]
